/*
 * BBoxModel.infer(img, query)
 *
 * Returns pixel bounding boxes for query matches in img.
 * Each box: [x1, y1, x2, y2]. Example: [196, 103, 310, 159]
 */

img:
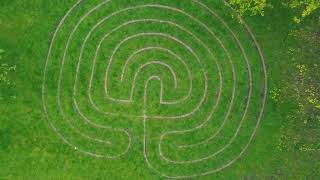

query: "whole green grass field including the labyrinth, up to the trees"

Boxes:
[0, 0, 317, 179]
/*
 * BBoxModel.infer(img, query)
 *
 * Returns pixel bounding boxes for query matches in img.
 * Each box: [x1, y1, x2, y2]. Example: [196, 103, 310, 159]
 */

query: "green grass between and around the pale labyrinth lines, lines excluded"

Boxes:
[0, 0, 311, 179]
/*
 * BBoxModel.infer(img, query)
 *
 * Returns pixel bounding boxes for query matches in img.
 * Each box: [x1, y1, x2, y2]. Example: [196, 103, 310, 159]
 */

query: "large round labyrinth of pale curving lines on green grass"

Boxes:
[42, 0, 267, 178]
